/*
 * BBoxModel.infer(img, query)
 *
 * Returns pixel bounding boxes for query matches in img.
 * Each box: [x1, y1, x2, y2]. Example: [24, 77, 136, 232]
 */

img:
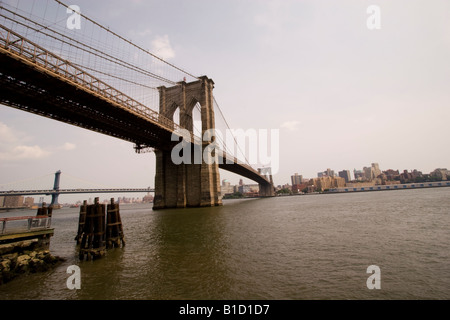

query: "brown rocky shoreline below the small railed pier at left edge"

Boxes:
[0, 239, 64, 285]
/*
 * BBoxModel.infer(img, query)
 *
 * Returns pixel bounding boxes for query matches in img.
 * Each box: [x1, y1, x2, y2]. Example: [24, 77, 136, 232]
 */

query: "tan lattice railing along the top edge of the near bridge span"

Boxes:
[0, 25, 185, 135]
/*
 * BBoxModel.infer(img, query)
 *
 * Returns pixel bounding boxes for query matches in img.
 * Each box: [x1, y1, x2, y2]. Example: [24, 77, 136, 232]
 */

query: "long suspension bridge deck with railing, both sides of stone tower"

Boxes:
[0, 26, 270, 188]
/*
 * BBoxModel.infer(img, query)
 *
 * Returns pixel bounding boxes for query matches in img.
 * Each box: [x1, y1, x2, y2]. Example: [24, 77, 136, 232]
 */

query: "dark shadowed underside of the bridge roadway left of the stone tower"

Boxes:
[0, 54, 173, 150]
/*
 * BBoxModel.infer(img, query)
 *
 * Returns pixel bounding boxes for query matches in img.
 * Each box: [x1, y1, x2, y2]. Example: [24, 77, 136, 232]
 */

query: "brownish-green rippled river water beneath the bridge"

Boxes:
[0, 188, 450, 299]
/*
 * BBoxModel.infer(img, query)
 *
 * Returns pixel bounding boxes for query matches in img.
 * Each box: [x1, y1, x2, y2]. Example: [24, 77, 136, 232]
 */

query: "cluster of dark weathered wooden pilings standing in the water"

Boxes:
[75, 198, 125, 260]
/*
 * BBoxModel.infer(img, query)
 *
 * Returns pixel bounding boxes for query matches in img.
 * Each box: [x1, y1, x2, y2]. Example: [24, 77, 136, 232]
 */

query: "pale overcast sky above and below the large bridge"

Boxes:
[0, 0, 450, 202]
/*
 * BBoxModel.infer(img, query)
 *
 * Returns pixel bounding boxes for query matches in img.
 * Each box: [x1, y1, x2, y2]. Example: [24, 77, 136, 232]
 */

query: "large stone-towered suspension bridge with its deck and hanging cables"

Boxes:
[0, 0, 274, 209]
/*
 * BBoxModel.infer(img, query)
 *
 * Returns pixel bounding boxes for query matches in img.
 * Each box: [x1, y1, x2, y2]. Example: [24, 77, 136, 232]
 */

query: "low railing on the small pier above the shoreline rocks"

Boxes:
[0, 216, 52, 234]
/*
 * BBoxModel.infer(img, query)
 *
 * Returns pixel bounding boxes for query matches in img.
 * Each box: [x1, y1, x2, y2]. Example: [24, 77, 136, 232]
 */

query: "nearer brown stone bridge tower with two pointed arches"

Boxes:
[153, 76, 222, 209]
